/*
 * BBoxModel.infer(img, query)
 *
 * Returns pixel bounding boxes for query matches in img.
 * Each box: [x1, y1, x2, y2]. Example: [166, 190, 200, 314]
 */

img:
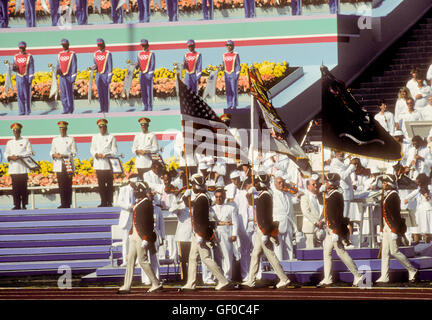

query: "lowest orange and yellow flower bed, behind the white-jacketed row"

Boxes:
[0, 157, 179, 188]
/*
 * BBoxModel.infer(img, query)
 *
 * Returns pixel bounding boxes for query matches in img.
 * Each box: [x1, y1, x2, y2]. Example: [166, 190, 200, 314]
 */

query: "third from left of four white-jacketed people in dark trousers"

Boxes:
[90, 119, 117, 207]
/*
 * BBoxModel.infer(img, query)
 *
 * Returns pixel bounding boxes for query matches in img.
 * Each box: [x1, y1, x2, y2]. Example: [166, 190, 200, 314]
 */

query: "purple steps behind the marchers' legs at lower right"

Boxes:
[262, 247, 432, 284]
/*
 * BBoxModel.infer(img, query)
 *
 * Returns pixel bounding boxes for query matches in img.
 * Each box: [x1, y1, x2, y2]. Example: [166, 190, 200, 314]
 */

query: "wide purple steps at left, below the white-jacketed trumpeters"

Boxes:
[0, 208, 121, 277]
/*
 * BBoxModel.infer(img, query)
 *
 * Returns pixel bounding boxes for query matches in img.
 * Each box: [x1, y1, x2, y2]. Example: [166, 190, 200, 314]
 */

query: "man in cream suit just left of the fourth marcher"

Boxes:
[300, 174, 325, 249]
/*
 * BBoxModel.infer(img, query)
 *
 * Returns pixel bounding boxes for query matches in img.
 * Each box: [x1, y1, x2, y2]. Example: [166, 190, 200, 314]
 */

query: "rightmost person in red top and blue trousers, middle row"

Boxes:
[223, 40, 241, 109]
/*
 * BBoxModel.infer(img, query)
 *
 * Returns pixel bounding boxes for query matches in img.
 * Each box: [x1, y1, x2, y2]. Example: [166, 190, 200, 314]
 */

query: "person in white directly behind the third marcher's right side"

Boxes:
[272, 176, 299, 260]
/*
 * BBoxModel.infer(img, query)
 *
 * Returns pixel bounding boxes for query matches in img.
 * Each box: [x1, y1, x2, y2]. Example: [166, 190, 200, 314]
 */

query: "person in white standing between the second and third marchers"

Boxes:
[212, 188, 238, 281]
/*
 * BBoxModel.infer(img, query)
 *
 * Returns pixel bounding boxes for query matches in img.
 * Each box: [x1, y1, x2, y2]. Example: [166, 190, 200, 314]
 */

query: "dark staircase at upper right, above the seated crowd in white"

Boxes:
[350, 10, 432, 114]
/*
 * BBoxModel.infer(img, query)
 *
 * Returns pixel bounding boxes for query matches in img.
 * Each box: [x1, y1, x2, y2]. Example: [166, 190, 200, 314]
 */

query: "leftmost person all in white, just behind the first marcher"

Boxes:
[115, 174, 137, 267]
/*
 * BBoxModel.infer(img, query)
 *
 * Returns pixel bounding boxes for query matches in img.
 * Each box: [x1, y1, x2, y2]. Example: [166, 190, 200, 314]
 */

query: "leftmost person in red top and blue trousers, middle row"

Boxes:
[13, 41, 34, 116]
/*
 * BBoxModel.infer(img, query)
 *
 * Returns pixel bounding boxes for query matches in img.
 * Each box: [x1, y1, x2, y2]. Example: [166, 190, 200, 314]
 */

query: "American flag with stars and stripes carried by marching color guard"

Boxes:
[178, 79, 248, 163]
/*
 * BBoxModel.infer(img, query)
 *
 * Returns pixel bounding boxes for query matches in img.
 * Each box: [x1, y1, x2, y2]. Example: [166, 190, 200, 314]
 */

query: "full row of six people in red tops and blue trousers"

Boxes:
[5, 38, 241, 115]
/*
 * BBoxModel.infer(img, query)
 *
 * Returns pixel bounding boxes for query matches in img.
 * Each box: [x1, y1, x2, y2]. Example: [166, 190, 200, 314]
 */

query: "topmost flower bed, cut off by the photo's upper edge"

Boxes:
[9, 0, 370, 17]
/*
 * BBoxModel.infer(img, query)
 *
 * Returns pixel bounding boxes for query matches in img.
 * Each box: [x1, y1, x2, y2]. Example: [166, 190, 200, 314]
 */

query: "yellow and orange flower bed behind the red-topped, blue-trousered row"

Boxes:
[0, 61, 295, 103]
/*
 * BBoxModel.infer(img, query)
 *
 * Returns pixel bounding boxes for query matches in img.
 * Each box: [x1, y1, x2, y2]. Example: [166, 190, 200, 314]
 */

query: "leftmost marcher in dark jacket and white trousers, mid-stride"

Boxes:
[118, 182, 162, 294]
